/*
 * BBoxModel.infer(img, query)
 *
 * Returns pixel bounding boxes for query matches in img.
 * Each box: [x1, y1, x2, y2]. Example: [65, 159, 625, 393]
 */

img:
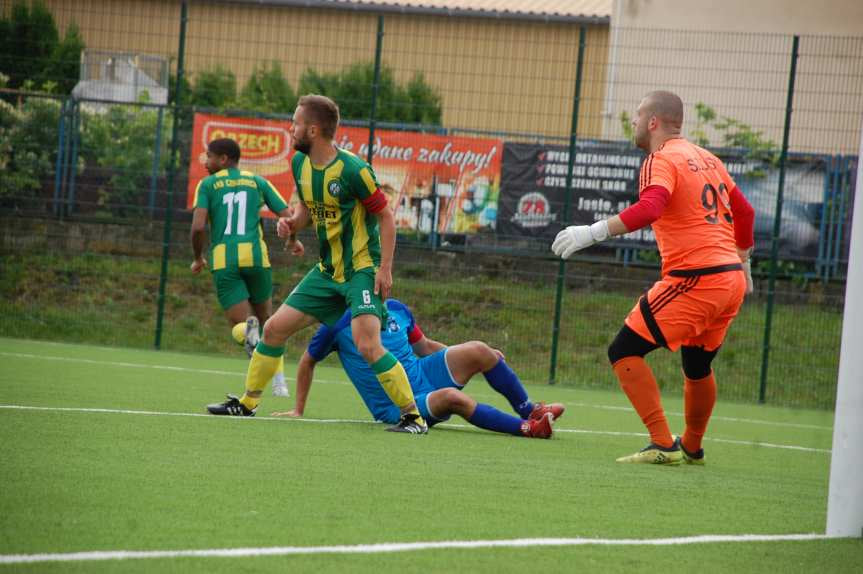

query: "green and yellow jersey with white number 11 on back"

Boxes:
[194, 167, 287, 271]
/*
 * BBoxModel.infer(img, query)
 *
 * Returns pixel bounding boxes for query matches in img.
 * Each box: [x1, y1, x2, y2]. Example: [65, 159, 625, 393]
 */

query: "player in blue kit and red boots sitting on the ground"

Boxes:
[274, 299, 564, 438]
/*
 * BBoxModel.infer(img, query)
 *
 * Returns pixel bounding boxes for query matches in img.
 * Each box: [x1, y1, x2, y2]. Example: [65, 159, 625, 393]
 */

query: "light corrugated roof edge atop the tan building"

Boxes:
[226, 0, 613, 24]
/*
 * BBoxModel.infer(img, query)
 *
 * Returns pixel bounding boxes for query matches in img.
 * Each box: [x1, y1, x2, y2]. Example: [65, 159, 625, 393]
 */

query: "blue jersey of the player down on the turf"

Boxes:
[307, 299, 422, 420]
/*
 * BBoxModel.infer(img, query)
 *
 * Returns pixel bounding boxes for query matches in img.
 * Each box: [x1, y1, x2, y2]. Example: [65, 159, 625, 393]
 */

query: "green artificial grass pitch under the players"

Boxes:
[0, 339, 863, 574]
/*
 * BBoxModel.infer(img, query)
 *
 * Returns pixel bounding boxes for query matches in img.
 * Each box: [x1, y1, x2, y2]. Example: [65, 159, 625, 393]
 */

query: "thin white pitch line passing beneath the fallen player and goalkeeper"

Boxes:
[0, 405, 830, 454]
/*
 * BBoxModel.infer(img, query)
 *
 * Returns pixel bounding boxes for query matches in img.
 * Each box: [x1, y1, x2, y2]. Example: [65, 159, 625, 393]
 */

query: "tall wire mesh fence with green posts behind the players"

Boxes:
[0, 1, 863, 414]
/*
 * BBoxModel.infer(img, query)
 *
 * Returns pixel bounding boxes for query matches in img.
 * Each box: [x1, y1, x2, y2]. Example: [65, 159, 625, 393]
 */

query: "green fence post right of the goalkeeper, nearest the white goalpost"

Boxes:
[758, 36, 800, 403]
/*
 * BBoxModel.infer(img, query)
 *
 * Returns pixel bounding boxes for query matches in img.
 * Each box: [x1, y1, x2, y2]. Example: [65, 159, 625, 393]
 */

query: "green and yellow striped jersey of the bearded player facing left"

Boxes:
[291, 149, 381, 283]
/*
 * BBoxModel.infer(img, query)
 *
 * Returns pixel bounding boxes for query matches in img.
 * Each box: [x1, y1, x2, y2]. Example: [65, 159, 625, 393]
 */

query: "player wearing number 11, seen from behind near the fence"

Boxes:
[190, 138, 302, 396]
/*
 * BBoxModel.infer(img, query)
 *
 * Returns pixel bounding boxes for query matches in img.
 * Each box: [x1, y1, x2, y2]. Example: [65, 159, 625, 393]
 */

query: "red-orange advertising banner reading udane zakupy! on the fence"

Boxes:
[187, 114, 503, 234]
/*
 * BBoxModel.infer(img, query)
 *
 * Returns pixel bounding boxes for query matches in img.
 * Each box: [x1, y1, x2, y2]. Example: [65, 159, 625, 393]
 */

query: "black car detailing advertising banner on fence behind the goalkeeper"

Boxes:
[497, 143, 833, 258]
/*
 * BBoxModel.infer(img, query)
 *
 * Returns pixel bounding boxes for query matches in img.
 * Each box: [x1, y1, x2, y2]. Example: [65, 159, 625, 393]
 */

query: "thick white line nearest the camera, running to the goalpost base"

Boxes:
[0, 534, 830, 564]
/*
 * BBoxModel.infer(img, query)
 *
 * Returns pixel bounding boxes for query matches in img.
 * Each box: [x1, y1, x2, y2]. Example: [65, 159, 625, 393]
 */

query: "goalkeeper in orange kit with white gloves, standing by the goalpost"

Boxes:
[552, 91, 755, 464]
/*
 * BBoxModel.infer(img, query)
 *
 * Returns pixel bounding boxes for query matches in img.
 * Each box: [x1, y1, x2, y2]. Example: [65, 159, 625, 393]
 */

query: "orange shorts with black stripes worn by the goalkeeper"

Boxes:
[626, 265, 746, 351]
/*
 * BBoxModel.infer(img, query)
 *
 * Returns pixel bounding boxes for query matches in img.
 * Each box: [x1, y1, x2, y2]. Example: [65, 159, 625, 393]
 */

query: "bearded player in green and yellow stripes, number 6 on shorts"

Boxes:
[207, 95, 428, 434]
